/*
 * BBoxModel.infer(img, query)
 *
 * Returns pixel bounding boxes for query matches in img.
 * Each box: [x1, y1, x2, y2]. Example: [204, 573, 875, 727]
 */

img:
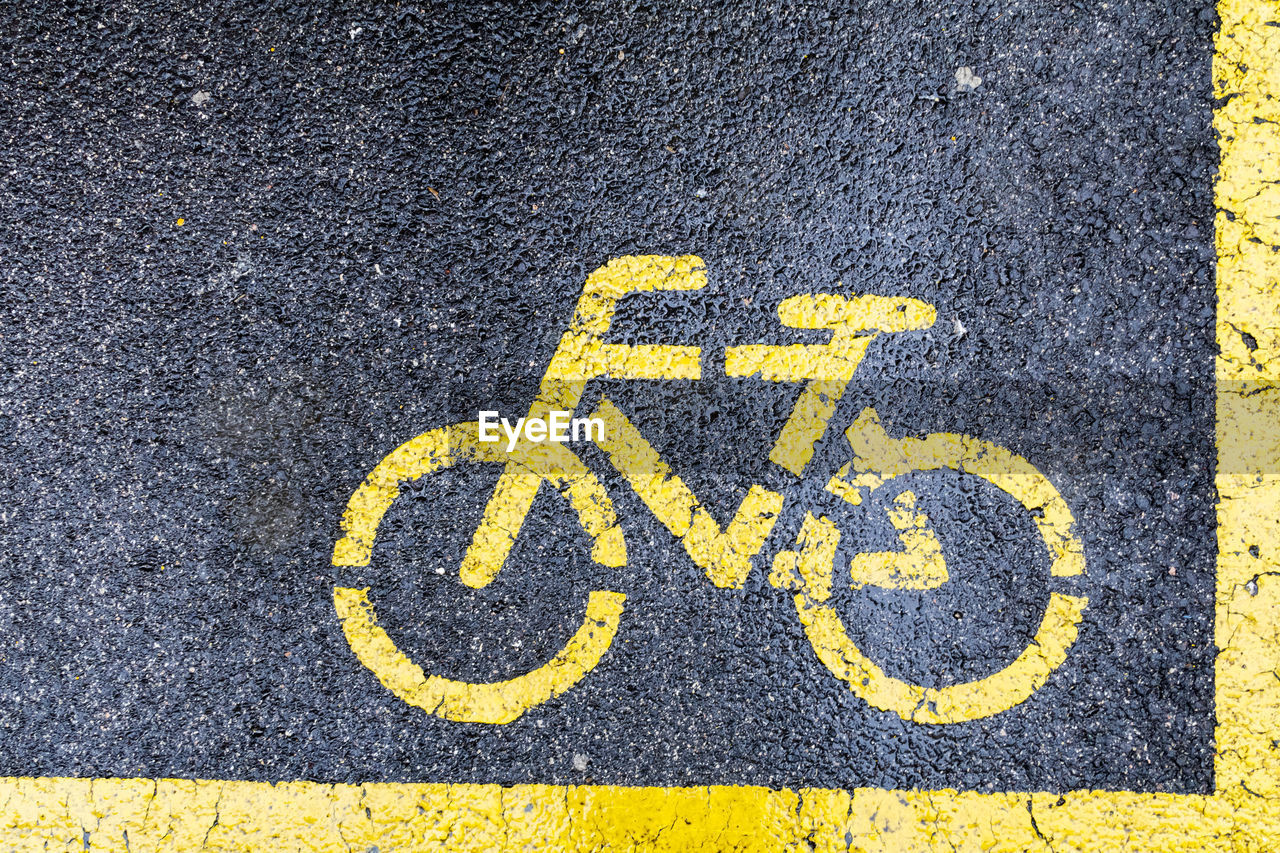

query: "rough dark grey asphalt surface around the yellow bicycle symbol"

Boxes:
[0, 0, 1216, 792]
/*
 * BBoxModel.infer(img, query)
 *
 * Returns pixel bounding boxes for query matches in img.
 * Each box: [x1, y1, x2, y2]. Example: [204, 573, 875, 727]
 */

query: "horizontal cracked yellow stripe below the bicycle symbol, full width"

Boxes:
[0, 779, 1280, 853]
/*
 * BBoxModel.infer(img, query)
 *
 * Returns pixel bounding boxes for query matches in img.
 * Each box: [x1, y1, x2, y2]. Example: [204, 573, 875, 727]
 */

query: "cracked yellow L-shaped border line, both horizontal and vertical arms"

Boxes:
[0, 0, 1280, 853]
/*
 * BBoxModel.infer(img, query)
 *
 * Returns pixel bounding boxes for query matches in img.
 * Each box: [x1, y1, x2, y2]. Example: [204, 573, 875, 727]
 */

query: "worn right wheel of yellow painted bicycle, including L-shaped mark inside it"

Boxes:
[776, 410, 1088, 724]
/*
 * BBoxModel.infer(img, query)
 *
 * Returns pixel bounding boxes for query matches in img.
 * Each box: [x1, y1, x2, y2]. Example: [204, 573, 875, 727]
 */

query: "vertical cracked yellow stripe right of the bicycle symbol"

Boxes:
[1213, 0, 1280, 804]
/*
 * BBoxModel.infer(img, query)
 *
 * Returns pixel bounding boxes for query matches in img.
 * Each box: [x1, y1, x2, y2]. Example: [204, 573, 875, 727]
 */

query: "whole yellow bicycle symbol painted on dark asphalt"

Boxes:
[333, 255, 1088, 724]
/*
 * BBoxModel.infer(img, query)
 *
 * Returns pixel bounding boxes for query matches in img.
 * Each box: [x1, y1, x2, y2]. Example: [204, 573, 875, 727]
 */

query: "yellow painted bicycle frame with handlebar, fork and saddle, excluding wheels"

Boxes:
[461, 255, 936, 588]
